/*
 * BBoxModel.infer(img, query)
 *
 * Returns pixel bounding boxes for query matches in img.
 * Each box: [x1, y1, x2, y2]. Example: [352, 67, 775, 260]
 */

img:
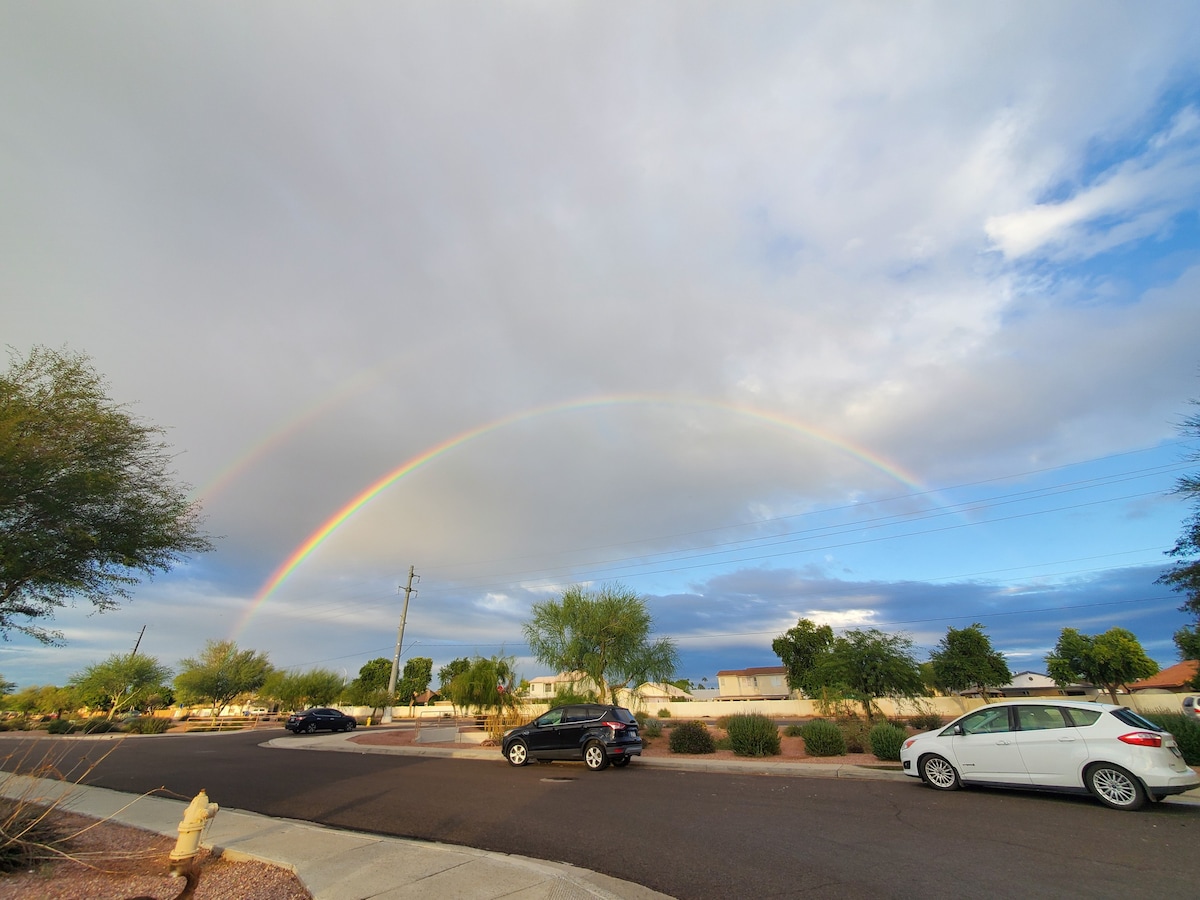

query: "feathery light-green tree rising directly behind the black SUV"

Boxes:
[524, 584, 679, 702]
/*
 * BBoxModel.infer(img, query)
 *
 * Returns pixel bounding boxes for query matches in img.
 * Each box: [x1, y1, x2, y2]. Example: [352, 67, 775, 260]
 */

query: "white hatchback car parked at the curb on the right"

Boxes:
[900, 698, 1200, 810]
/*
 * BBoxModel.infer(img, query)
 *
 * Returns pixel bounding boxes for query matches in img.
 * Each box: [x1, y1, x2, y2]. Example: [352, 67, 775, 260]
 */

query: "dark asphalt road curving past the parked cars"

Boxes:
[0, 730, 1200, 900]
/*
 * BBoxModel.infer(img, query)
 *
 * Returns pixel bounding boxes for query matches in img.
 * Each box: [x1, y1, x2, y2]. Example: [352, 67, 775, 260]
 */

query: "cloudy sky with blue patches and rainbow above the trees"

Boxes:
[0, 0, 1200, 686]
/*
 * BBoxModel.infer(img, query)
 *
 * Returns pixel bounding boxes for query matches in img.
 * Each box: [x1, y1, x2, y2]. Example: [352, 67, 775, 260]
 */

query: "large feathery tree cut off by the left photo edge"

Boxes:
[0, 347, 211, 644]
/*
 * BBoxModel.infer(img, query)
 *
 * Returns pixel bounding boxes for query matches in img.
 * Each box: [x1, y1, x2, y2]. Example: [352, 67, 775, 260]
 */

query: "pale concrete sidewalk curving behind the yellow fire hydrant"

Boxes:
[0, 773, 666, 900]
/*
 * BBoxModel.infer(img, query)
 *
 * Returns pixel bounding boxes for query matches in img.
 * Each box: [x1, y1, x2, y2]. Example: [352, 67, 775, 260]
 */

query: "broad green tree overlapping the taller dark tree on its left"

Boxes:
[812, 628, 922, 719]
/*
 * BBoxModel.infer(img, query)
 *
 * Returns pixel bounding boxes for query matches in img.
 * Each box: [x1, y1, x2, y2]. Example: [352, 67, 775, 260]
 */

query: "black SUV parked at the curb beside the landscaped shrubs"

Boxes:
[503, 703, 642, 772]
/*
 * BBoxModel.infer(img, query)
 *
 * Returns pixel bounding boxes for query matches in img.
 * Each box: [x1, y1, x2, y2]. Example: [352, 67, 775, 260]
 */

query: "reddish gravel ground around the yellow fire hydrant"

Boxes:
[0, 811, 312, 900]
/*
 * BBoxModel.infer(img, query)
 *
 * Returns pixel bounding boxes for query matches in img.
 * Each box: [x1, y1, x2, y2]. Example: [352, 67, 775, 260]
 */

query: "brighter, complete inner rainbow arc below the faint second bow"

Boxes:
[233, 394, 928, 637]
